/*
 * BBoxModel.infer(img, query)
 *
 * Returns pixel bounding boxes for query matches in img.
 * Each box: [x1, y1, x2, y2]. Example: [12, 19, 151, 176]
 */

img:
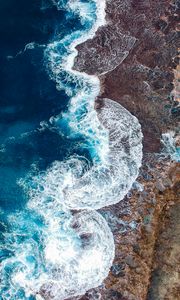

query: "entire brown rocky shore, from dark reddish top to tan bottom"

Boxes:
[72, 0, 180, 300]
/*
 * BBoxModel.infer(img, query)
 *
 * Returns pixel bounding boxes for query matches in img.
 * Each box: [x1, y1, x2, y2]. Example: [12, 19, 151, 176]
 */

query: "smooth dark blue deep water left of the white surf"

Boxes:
[0, 0, 89, 211]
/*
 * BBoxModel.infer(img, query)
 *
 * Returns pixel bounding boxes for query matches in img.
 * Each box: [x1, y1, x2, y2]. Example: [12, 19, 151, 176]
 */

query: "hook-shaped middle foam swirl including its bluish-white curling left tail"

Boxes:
[29, 99, 142, 211]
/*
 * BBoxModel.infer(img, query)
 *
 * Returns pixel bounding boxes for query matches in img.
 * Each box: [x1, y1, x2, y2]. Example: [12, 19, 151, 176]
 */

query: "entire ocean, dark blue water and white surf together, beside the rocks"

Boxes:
[0, 0, 142, 300]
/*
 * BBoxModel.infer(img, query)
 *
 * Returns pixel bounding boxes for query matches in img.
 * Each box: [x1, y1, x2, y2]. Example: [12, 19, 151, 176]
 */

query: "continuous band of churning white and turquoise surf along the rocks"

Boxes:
[0, 0, 142, 300]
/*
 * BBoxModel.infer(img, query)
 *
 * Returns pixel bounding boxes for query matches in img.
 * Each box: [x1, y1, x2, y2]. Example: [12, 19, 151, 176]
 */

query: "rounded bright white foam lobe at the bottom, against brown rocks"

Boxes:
[41, 212, 114, 300]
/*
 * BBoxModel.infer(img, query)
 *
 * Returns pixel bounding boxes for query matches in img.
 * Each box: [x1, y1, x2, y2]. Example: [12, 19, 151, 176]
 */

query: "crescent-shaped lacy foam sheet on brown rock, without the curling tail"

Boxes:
[63, 99, 142, 209]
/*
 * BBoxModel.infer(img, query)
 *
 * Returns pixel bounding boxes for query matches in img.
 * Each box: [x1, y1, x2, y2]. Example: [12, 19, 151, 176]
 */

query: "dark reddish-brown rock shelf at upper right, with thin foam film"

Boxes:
[75, 0, 180, 152]
